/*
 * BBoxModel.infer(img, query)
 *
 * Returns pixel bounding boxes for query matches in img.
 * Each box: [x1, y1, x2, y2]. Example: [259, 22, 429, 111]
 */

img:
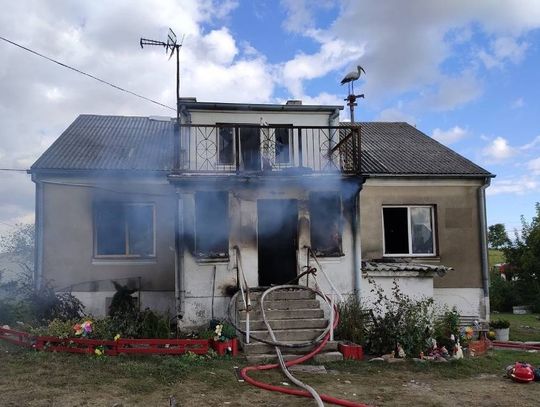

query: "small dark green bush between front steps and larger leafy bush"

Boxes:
[335, 294, 368, 345]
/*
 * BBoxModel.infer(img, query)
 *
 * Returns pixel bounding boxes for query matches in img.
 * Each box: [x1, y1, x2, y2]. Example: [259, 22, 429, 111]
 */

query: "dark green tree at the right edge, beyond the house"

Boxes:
[503, 202, 540, 312]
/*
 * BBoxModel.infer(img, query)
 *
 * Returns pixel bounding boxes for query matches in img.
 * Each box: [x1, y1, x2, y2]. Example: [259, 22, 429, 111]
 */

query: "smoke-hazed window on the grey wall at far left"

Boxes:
[94, 202, 155, 257]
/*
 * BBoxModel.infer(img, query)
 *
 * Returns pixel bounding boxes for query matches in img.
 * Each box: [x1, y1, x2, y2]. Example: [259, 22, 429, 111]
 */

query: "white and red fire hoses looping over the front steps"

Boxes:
[229, 285, 367, 407]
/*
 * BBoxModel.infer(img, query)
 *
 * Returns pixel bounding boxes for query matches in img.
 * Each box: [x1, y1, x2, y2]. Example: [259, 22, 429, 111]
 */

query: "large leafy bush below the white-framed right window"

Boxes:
[366, 279, 434, 356]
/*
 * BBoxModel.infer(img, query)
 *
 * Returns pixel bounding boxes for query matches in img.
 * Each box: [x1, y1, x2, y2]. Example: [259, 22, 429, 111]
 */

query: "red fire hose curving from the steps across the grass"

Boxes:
[240, 308, 368, 407]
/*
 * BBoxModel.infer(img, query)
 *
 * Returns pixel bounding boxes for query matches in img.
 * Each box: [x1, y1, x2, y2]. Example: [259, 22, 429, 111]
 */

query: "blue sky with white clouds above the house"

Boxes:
[0, 0, 540, 236]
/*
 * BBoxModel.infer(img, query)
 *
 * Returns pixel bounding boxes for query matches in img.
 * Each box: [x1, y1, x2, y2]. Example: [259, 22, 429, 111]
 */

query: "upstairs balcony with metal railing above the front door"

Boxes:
[176, 124, 360, 175]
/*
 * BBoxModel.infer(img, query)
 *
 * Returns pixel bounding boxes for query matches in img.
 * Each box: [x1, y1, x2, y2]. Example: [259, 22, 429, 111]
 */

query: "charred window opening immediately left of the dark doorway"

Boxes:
[195, 191, 229, 258]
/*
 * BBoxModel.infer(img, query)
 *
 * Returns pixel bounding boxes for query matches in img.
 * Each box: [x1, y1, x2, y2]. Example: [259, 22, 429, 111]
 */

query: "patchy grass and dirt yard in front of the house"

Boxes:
[0, 341, 540, 406]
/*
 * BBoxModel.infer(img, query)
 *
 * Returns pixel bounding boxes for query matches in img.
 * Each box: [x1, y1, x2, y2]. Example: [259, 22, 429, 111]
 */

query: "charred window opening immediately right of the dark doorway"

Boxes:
[309, 192, 343, 257]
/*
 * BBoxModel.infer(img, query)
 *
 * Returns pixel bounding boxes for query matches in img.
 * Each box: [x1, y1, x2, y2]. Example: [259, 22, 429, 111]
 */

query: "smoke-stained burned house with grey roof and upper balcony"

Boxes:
[31, 98, 492, 326]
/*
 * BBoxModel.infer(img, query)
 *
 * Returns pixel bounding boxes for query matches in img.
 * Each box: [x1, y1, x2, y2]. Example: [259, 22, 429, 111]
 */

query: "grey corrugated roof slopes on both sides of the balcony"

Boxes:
[31, 115, 491, 177]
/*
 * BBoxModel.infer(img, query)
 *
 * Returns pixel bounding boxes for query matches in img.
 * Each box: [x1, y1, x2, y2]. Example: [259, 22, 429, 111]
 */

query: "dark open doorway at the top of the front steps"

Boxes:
[257, 199, 298, 287]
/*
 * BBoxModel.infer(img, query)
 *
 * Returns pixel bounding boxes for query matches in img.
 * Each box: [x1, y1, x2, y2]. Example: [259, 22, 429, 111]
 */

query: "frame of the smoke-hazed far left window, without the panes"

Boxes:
[92, 201, 157, 260]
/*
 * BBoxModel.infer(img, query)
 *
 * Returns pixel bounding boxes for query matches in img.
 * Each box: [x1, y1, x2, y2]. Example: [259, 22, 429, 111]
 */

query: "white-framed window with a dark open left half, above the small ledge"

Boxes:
[383, 206, 435, 256]
